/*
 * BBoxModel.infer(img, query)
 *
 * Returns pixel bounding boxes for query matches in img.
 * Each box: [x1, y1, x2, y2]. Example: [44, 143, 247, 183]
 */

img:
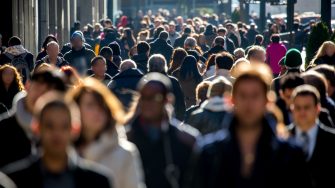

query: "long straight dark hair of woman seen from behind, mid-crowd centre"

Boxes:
[180, 55, 202, 82]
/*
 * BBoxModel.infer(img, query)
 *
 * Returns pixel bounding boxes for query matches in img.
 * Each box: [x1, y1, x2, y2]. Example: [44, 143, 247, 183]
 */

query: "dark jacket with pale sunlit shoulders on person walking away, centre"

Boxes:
[185, 97, 227, 134]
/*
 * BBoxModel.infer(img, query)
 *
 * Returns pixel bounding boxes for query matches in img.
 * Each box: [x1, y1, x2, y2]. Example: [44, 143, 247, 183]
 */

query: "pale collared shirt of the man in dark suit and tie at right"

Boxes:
[295, 120, 319, 160]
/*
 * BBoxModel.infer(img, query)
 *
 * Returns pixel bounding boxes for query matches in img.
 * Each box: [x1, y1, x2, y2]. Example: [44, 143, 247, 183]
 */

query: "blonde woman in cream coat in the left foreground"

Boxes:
[68, 78, 143, 188]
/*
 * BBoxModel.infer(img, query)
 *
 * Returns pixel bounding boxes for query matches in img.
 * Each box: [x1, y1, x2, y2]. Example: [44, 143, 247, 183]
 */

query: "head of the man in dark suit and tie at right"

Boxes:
[291, 85, 321, 131]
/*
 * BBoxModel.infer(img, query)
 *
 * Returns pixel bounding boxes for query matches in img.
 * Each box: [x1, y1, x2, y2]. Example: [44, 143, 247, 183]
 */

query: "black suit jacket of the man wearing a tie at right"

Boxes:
[289, 123, 335, 188]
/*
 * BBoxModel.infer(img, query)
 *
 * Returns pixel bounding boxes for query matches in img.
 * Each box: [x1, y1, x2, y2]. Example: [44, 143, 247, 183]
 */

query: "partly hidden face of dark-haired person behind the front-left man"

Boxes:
[26, 81, 50, 112]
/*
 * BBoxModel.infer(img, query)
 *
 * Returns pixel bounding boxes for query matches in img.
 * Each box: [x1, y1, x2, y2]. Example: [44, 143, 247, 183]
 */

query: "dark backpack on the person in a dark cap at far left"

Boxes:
[5, 52, 30, 83]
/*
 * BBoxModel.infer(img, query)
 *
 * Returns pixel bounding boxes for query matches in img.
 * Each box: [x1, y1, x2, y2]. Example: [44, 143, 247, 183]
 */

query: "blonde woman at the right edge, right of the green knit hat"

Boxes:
[311, 41, 335, 66]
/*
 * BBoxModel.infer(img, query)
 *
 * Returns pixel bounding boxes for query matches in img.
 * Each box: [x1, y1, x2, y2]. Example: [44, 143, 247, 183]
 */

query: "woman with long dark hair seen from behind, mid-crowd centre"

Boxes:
[172, 55, 202, 108]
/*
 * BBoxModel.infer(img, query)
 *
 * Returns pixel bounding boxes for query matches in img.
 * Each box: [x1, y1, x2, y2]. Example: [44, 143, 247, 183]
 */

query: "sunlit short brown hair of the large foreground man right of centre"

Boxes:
[233, 63, 273, 95]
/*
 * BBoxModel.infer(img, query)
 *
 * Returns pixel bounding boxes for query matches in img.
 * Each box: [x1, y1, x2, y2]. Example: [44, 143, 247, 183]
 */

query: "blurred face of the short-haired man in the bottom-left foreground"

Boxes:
[39, 107, 71, 156]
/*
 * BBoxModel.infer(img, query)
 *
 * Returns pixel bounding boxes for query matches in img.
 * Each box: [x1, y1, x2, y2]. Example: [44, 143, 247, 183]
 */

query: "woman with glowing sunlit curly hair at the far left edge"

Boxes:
[0, 65, 24, 110]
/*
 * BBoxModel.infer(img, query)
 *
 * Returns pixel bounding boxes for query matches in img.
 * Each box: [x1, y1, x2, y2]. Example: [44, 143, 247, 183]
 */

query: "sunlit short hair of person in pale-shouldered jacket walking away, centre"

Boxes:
[207, 76, 232, 98]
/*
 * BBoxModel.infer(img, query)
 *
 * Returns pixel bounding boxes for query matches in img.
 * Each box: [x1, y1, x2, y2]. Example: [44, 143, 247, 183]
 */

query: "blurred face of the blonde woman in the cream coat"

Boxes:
[79, 92, 107, 137]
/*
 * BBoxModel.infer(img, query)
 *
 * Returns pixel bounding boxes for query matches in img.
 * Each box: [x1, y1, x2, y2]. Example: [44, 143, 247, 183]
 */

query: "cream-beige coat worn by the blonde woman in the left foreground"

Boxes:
[83, 127, 145, 188]
